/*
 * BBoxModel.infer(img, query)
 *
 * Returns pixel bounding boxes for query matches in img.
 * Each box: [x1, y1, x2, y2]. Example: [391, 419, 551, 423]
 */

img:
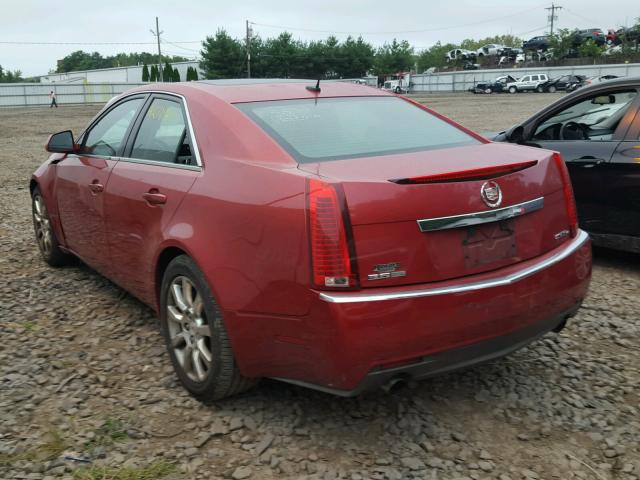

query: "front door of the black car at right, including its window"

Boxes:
[531, 88, 637, 232]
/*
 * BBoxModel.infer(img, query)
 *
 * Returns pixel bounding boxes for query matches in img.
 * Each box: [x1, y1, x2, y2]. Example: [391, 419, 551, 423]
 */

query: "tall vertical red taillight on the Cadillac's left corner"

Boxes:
[307, 179, 357, 288]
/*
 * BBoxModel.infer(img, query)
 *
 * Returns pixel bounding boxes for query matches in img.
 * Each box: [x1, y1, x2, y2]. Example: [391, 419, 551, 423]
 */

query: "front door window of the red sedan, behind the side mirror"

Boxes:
[82, 98, 144, 157]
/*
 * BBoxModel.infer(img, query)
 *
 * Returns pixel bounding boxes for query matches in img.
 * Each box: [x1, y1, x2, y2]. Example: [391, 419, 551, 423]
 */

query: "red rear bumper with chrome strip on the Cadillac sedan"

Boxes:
[268, 231, 591, 396]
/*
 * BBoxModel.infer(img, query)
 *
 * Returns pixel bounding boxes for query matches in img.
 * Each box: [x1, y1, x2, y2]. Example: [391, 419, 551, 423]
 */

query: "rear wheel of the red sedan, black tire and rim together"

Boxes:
[160, 255, 257, 403]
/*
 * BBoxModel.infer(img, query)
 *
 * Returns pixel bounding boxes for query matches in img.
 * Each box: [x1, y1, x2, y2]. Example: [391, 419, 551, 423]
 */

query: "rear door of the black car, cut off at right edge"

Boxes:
[602, 95, 640, 240]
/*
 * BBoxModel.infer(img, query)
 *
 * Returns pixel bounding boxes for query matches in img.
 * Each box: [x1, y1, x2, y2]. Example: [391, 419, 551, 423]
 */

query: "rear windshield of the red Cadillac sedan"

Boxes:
[235, 97, 480, 163]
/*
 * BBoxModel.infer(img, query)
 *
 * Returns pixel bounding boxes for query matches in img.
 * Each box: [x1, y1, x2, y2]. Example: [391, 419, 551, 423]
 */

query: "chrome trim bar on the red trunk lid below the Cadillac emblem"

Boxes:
[416, 197, 544, 232]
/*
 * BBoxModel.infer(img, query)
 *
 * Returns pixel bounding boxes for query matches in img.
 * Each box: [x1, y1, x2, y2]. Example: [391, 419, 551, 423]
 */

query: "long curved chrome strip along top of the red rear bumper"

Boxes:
[319, 230, 589, 303]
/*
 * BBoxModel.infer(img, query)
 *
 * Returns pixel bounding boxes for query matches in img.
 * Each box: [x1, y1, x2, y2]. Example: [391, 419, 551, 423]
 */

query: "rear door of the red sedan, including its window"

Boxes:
[105, 94, 201, 305]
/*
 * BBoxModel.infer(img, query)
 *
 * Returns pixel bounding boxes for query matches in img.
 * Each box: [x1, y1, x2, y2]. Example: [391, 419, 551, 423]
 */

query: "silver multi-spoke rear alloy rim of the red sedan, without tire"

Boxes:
[166, 275, 213, 382]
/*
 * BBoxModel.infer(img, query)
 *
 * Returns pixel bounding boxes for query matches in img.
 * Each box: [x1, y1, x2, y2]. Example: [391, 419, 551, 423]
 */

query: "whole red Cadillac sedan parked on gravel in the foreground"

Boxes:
[30, 80, 591, 401]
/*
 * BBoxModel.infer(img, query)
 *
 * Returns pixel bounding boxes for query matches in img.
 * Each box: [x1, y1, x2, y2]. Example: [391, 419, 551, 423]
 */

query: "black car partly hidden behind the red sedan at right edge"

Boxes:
[494, 77, 640, 253]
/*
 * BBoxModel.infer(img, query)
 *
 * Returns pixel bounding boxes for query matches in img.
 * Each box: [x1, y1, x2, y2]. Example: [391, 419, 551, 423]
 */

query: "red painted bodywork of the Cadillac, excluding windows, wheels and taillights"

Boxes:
[32, 82, 591, 392]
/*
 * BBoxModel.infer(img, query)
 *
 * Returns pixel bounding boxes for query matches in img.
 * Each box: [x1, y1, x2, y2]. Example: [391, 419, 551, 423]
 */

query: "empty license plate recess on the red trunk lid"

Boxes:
[462, 220, 517, 269]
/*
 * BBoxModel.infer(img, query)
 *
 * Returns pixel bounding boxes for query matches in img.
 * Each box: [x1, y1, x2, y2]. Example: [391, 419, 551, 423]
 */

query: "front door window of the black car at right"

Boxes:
[533, 90, 638, 141]
